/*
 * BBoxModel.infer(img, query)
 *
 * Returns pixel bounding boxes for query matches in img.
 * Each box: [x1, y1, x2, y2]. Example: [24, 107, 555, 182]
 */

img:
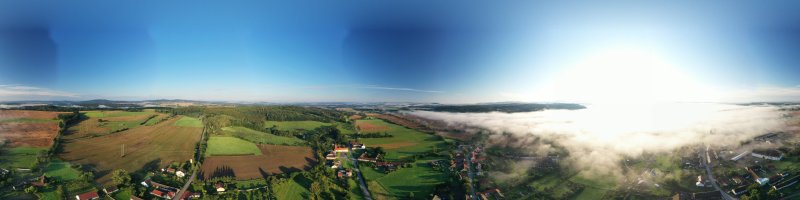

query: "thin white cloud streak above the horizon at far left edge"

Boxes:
[0, 85, 78, 100]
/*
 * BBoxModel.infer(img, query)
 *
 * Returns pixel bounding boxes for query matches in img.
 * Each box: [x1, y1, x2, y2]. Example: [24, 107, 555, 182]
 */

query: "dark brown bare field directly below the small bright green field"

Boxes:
[201, 145, 317, 180]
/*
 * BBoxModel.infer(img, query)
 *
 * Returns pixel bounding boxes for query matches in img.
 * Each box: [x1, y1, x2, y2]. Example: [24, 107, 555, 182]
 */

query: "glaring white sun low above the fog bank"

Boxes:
[548, 47, 709, 104]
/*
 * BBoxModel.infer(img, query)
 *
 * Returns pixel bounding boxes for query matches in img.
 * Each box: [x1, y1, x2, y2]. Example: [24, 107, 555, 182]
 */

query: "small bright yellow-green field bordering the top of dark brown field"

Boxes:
[206, 136, 261, 156]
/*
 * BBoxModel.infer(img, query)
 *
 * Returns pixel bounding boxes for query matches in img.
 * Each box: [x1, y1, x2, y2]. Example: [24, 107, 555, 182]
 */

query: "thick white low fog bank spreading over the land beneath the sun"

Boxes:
[410, 103, 786, 178]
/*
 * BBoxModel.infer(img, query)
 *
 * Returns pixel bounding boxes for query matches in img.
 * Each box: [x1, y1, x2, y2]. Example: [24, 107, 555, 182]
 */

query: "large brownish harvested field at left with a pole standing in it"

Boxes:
[58, 117, 202, 184]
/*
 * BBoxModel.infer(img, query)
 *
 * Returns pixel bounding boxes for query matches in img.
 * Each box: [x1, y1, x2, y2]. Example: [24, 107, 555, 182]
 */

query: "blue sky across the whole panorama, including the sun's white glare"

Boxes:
[0, 1, 800, 103]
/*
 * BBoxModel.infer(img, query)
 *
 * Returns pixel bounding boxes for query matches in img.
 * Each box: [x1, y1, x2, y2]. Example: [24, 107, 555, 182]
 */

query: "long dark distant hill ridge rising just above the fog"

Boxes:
[412, 103, 586, 113]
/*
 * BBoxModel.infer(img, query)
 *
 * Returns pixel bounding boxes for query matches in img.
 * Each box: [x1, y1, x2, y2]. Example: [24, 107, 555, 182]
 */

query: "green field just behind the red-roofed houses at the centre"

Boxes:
[359, 119, 447, 160]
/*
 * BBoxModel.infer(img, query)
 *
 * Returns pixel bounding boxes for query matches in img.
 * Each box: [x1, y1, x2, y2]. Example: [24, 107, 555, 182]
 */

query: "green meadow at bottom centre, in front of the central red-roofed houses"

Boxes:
[362, 159, 447, 199]
